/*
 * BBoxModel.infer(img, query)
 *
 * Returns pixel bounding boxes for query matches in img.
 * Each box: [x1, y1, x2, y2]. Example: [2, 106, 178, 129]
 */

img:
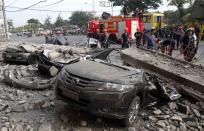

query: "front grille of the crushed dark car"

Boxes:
[63, 71, 104, 88]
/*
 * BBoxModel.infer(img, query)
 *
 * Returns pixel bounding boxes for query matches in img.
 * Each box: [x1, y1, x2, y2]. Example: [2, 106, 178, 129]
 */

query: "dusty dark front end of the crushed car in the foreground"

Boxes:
[56, 60, 147, 125]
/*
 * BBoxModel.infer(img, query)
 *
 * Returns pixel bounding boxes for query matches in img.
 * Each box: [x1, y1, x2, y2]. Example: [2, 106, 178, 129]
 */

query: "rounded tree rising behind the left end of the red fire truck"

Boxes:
[69, 11, 94, 27]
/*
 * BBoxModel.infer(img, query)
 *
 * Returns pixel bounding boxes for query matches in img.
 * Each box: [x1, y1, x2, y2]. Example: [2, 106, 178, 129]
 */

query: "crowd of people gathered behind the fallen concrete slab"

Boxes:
[122, 24, 201, 62]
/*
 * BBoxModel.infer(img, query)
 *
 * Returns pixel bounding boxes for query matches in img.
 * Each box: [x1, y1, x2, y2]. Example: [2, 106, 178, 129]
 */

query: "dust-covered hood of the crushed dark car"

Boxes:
[65, 61, 143, 84]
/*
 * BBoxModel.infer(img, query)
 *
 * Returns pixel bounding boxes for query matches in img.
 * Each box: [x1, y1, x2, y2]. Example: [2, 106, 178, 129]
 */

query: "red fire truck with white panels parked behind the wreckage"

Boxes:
[87, 16, 144, 42]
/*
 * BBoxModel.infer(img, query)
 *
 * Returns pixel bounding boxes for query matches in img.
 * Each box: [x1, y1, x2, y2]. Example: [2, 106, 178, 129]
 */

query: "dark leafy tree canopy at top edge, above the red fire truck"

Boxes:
[109, 0, 162, 11]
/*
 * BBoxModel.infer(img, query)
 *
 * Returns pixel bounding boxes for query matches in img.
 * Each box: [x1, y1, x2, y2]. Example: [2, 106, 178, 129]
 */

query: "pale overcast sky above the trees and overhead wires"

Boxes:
[5, 0, 175, 26]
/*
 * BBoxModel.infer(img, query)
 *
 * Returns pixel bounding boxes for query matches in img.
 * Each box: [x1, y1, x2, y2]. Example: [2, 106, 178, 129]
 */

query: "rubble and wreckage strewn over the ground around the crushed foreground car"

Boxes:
[0, 41, 204, 131]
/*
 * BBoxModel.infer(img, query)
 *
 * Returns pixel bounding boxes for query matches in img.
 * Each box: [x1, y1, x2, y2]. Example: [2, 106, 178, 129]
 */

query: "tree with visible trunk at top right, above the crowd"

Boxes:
[168, 0, 194, 23]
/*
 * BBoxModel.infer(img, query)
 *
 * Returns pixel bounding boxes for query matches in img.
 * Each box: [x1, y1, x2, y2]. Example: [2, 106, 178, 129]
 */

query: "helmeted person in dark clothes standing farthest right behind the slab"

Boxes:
[181, 28, 196, 62]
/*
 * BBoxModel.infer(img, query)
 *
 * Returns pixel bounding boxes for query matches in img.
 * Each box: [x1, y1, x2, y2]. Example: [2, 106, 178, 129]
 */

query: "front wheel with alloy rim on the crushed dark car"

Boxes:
[123, 96, 141, 127]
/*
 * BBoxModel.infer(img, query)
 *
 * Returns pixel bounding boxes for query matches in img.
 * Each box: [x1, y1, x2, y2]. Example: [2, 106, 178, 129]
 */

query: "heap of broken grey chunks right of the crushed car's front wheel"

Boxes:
[142, 99, 204, 131]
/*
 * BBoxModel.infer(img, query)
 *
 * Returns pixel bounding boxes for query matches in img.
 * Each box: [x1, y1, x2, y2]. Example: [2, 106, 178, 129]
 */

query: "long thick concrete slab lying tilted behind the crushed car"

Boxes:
[121, 48, 204, 93]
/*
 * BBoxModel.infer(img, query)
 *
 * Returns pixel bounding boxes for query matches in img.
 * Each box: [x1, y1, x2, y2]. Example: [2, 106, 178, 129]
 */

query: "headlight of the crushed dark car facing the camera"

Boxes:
[98, 83, 134, 92]
